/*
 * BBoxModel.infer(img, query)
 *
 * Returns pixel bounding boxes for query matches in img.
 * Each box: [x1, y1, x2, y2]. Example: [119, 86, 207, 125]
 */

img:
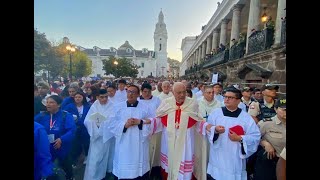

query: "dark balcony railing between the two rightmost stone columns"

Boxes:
[248, 28, 274, 54]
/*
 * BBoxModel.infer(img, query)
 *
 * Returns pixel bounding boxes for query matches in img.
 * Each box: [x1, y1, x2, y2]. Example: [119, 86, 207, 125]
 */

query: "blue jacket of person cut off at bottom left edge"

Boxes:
[33, 122, 53, 180]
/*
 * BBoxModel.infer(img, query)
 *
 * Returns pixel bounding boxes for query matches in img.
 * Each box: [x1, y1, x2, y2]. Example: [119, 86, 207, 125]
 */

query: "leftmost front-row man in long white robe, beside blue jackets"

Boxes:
[84, 89, 115, 180]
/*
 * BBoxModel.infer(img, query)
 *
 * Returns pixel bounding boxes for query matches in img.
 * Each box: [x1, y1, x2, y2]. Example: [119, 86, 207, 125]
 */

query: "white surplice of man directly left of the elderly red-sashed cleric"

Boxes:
[108, 101, 152, 179]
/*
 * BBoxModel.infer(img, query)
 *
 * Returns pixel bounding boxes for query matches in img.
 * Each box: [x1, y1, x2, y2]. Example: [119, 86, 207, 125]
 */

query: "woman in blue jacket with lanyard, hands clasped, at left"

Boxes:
[34, 95, 76, 180]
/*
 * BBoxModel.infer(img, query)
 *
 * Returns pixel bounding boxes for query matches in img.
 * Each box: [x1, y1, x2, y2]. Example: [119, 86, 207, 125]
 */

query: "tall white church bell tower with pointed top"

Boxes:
[153, 10, 168, 77]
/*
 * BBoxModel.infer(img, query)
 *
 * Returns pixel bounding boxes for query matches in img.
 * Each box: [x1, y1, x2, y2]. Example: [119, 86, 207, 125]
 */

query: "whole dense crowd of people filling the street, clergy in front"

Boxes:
[34, 79, 286, 180]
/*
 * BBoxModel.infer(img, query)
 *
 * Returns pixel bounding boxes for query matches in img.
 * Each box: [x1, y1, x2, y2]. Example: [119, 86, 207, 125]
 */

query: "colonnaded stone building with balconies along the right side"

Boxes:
[180, 0, 286, 92]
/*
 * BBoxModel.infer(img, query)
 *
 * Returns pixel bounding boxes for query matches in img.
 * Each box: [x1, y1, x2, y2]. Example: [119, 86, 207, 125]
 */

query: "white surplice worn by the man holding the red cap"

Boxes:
[207, 108, 261, 180]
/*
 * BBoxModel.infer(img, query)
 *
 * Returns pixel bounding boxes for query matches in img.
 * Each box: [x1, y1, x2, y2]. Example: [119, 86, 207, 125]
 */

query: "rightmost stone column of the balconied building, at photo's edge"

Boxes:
[274, 0, 286, 45]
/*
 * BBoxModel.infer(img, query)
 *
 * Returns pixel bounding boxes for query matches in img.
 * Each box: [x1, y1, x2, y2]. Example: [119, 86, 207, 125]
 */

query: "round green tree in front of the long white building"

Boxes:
[102, 56, 140, 78]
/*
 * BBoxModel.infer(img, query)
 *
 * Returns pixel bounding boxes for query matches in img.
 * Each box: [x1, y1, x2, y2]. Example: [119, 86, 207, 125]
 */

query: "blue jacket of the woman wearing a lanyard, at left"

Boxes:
[34, 109, 76, 161]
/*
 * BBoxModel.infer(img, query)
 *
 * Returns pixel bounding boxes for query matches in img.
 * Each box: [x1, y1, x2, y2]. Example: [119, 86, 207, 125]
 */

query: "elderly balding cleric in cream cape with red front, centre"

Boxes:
[151, 82, 211, 180]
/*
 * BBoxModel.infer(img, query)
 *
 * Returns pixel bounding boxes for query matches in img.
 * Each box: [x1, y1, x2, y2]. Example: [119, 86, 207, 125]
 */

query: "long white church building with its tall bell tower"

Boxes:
[79, 10, 168, 78]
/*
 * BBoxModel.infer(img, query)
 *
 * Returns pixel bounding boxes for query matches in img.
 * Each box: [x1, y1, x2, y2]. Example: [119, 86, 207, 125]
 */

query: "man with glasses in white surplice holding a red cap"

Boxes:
[207, 87, 261, 180]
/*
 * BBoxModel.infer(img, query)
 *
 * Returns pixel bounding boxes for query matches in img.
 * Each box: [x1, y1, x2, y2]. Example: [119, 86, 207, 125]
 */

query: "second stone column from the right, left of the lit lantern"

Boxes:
[246, 0, 260, 53]
